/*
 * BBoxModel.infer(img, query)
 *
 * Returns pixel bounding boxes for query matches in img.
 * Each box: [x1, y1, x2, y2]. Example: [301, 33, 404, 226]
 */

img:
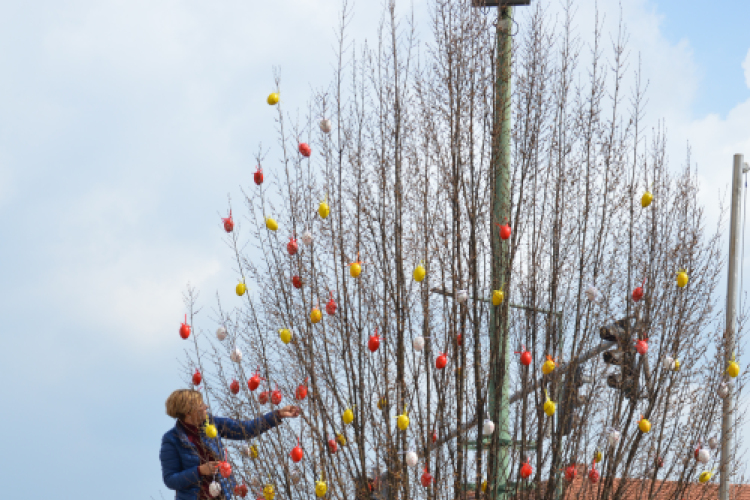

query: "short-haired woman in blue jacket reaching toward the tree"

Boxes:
[159, 389, 299, 500]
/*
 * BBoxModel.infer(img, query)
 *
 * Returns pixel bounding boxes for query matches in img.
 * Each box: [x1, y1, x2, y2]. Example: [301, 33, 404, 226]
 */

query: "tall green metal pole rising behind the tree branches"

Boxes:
[488, 7, 513, 500]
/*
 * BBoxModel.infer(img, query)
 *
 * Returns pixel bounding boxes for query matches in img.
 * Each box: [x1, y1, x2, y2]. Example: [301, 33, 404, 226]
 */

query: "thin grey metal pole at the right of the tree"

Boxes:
[719, 155, 744, 500]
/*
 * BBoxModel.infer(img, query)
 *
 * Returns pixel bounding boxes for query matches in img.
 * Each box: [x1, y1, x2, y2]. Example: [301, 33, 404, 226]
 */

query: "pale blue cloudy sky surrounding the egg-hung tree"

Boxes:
[0, 0, 750, 500]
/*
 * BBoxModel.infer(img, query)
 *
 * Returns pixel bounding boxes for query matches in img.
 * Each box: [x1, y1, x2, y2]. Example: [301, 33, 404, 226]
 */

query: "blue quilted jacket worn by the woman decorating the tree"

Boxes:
[159, 412, 281, 500]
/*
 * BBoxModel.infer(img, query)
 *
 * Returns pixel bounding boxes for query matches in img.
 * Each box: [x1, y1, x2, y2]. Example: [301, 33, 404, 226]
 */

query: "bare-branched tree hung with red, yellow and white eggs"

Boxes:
[180, 0, 742, 500]
